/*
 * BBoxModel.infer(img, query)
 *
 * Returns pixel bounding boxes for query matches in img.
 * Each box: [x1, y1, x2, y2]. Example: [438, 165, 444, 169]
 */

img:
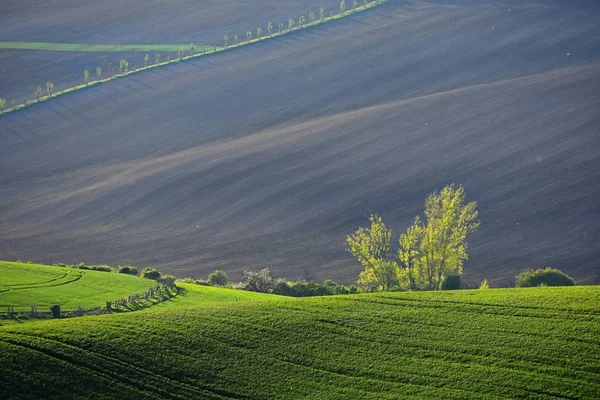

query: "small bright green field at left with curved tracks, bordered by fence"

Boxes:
[0, 262, 156, 314]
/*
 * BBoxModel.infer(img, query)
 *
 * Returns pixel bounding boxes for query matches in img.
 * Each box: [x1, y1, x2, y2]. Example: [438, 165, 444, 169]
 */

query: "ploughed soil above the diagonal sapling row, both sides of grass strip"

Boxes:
[0, 0, 339, 104]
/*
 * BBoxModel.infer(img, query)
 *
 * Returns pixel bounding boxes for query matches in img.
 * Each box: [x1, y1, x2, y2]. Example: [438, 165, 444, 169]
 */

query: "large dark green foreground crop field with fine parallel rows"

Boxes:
[0, 287, 600, 399]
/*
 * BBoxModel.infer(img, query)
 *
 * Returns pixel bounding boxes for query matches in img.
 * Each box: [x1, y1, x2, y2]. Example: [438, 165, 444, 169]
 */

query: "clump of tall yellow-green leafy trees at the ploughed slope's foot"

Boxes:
[346, 185, 479, 291]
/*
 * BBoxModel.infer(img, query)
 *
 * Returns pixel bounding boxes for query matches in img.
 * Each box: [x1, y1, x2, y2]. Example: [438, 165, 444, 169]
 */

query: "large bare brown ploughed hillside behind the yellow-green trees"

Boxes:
[0, 0, 600, 282]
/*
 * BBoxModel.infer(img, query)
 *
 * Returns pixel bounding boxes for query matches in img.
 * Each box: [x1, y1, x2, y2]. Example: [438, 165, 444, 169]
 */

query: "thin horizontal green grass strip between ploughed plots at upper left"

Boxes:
[0, 42, 203, 52]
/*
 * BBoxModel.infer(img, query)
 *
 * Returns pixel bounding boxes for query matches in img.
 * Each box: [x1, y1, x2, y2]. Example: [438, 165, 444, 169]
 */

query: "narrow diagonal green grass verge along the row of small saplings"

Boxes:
[0, 0, 390, 116]
